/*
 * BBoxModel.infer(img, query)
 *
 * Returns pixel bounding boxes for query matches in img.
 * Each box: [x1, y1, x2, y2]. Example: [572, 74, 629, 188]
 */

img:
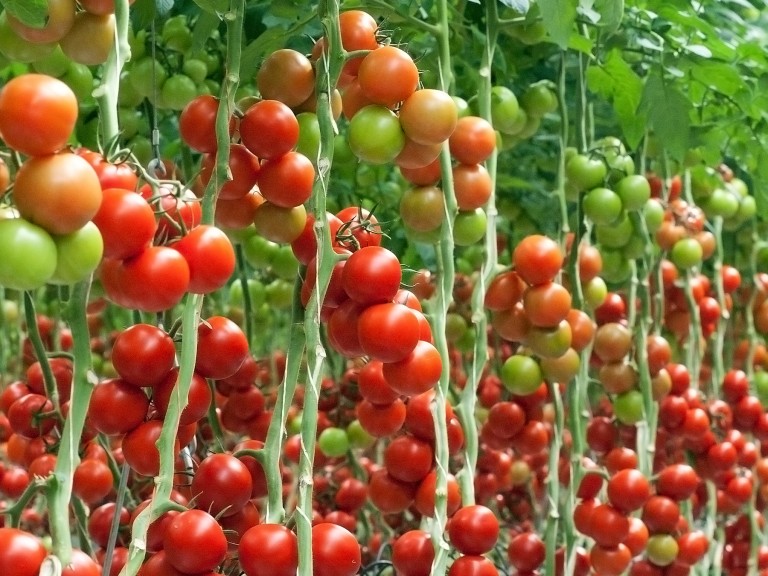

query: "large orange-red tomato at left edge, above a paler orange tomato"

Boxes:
[0, 74, 78, 156]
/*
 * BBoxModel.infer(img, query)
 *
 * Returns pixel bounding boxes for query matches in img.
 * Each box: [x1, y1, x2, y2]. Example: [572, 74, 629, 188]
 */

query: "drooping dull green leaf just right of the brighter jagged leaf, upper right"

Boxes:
[638, 74, 692, 160]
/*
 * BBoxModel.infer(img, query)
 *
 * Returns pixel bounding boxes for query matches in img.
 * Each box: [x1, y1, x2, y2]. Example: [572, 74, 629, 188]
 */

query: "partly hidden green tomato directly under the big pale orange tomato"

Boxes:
[49, 222, 104, 284]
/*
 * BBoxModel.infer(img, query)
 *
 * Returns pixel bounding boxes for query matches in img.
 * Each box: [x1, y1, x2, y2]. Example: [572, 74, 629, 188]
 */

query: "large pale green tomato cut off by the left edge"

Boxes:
[0, 218, 57, 290]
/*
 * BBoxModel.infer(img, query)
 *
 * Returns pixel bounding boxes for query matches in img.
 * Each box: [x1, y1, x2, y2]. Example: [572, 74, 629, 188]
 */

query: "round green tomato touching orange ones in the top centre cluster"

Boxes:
[348, 104, 405, 164]
